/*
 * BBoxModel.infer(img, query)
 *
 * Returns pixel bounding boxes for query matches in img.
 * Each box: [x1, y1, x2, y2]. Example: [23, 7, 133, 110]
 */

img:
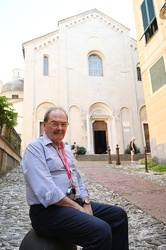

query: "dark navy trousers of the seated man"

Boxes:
[30, 202, 129, 250]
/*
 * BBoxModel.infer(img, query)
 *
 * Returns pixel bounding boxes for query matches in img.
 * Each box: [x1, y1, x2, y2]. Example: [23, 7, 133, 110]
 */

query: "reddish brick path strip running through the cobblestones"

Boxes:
[77, 161, 166, 224]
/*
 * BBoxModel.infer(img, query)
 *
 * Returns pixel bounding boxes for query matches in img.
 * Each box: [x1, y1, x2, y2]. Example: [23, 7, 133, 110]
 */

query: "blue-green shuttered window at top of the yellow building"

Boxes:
[141, 0, 158, 43]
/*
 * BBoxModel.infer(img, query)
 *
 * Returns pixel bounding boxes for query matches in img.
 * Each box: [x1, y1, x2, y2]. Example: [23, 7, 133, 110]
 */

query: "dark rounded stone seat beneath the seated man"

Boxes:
[19, 229, 77, 250]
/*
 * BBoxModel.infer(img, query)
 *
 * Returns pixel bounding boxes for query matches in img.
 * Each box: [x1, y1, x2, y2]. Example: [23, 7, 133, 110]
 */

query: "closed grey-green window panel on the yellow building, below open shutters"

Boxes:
[150, 57, 166, 93]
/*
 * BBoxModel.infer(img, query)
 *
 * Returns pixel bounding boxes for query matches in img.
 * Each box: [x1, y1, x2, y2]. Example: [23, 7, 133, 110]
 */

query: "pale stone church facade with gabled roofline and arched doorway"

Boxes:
[22, 9, 149, 154]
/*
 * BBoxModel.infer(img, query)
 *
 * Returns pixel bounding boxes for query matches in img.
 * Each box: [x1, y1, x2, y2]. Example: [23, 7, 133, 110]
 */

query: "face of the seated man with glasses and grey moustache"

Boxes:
[43, 110, 68, 146]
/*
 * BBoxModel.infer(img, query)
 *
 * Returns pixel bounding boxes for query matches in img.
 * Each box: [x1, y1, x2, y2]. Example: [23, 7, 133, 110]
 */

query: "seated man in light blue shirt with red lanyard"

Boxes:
[21, 106, 129, 250]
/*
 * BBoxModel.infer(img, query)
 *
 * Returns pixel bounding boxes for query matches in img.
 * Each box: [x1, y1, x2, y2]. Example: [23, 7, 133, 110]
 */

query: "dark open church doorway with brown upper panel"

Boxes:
[93, 121, 107, 154]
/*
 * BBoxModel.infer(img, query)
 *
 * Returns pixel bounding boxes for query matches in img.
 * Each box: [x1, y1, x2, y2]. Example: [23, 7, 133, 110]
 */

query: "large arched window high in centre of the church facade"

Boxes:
[88, 54, 103, 76]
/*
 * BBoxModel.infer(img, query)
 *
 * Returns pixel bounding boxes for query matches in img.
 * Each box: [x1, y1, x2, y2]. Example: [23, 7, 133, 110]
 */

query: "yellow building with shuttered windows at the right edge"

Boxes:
[132, 0, 166, 163]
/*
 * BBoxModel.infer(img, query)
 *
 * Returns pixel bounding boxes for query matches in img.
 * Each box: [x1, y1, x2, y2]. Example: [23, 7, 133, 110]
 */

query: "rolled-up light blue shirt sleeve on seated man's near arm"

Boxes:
[21, 143, 65, 207]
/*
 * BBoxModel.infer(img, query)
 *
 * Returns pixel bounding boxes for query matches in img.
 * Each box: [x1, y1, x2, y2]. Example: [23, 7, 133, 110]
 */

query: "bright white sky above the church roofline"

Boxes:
[0, 0, 136, 84]
